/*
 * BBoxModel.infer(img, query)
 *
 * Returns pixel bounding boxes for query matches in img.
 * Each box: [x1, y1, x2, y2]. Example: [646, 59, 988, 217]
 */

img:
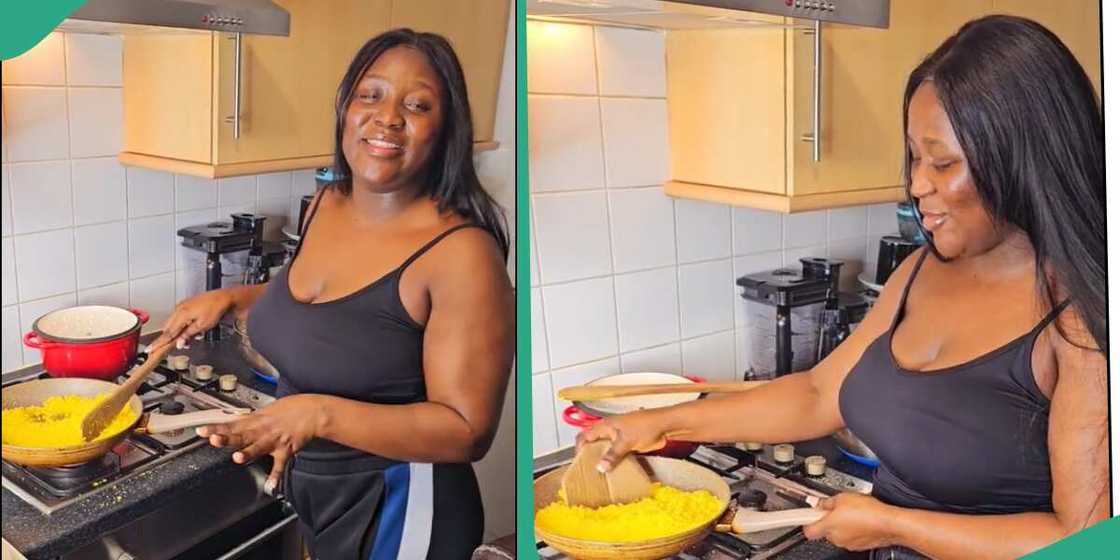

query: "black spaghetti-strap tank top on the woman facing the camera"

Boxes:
[249, 196, 477, 404]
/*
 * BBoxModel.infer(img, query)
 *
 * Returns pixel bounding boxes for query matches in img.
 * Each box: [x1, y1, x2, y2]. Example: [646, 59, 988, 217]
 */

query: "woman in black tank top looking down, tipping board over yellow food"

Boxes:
[580, 16, 1110, 559]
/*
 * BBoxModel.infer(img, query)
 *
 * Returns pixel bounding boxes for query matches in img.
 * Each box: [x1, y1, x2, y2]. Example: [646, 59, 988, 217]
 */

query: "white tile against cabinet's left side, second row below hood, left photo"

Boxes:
[66, 87, 124, 158]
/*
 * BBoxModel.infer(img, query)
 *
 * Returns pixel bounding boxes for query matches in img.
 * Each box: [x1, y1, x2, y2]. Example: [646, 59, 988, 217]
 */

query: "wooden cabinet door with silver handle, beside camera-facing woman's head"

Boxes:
[213, 0, 391, 164]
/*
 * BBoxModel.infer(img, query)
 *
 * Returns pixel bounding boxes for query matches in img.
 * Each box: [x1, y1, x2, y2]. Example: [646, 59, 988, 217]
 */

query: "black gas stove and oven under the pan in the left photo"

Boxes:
[2, 358, 300, 560]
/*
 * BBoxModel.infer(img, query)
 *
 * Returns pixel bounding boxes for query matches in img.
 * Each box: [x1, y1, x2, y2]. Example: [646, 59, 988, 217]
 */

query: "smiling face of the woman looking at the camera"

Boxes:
[343, 46, 444, 192]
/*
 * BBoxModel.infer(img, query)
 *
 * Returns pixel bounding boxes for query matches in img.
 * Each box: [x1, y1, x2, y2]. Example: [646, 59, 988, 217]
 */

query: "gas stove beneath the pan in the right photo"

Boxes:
[536, 445, 871, 560]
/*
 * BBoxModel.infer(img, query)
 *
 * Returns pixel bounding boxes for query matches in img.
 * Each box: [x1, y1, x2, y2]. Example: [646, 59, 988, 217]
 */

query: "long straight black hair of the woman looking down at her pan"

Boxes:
[903, 16, 1108, 353]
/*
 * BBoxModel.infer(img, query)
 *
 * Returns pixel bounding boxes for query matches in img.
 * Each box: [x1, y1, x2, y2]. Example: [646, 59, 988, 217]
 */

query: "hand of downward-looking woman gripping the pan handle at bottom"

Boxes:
[804, 493, 895, 550]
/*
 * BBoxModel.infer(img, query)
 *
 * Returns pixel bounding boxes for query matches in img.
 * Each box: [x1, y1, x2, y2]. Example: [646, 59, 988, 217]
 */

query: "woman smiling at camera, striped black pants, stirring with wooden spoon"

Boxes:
[157, 29, 514, 560]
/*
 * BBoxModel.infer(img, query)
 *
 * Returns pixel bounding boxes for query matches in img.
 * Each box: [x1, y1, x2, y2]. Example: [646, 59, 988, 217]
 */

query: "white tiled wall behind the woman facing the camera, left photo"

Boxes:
[0, 32, 514, 371]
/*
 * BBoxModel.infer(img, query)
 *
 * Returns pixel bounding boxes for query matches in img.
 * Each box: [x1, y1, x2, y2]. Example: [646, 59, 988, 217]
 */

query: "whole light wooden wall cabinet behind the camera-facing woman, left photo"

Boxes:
[119, 0, 510, 177]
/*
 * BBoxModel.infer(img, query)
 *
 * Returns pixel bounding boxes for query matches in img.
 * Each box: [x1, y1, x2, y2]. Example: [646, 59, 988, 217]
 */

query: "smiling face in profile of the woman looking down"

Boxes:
[906, 82, 1001, 260]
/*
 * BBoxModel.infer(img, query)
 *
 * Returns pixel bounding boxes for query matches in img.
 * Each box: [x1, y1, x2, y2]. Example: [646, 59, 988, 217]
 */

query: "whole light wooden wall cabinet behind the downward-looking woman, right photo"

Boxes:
[664, 0, 1100, 213]
